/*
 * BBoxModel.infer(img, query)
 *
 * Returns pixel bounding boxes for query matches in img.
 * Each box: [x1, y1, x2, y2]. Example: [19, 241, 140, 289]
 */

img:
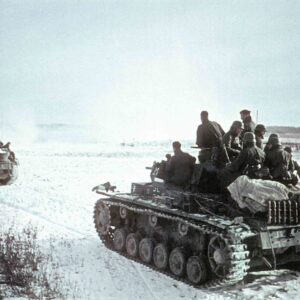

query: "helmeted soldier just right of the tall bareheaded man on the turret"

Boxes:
[222, 121, 243, 163]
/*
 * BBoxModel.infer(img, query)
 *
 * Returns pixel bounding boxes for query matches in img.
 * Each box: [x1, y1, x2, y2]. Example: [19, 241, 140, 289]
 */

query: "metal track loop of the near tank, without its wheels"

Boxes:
[94, 199, 250, 289]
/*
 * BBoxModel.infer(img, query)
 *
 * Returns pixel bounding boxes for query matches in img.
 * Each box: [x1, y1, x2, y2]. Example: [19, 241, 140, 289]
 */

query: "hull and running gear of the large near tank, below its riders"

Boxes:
[93, 166, 300, 288]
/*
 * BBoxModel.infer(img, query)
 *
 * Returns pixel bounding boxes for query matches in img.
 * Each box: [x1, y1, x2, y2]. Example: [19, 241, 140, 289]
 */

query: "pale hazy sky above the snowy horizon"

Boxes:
[0, 0, 300, 138]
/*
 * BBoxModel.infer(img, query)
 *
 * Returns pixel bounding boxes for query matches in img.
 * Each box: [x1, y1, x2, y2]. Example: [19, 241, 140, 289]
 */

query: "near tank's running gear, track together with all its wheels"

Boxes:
[94, 198, 250, 288]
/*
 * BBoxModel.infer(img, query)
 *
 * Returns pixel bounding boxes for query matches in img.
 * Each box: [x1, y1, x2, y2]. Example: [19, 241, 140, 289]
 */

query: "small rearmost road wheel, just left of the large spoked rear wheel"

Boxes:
[186, 256, 207, 284]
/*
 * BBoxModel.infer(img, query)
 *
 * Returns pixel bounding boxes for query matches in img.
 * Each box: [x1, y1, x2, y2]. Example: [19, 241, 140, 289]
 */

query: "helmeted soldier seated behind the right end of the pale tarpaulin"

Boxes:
[265, 136, 299, 185]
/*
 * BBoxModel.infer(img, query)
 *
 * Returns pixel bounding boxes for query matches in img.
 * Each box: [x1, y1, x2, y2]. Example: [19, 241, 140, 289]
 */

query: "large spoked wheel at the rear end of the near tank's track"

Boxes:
[208, 236, 230, 278]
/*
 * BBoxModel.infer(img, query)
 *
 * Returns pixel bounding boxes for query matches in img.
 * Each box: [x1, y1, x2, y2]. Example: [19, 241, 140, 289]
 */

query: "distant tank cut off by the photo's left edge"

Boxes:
[0, 147, 19, 186]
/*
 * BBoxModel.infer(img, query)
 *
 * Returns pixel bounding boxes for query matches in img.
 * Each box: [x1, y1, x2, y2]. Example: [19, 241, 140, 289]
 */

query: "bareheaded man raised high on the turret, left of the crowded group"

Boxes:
[196, 111, 225, 162]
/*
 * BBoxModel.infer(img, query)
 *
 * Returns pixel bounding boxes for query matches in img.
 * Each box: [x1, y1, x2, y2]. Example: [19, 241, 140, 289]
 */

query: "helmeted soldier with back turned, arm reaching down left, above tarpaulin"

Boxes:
[220, 132, 267, 190]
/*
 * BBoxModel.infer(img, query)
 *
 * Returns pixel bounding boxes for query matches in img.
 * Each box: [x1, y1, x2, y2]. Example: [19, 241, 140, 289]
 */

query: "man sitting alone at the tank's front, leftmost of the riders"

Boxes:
[165, 141, 196, 188]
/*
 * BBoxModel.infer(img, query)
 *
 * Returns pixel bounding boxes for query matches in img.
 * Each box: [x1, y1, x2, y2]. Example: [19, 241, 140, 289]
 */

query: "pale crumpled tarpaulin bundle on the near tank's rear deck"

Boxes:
[227, 175, 291, 213]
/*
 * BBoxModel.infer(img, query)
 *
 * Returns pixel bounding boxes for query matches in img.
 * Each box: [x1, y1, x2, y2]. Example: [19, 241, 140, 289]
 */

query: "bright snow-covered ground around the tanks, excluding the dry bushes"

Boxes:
[0, 142, 300, 300]
